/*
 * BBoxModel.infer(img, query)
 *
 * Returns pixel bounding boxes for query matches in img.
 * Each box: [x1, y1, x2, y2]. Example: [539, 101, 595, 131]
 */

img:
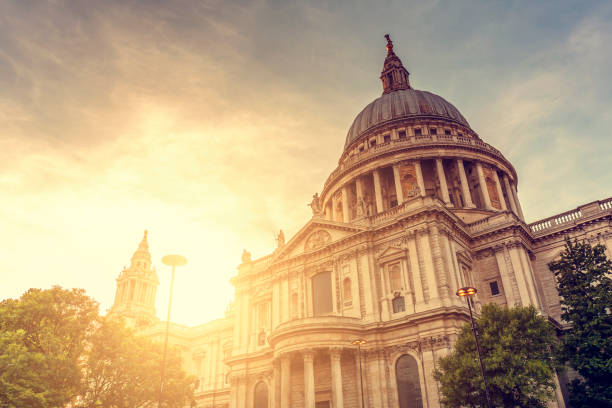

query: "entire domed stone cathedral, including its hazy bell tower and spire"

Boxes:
[111, 37, 612, 408]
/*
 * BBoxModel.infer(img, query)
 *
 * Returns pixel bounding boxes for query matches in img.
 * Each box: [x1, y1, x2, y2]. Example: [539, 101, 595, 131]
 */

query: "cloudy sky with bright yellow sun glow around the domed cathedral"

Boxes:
[0, 0, 612, 325]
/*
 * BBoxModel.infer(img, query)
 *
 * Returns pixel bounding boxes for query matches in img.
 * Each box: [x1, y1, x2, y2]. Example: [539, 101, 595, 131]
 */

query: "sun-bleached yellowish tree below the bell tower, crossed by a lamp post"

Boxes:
[75, 319, 195, 408]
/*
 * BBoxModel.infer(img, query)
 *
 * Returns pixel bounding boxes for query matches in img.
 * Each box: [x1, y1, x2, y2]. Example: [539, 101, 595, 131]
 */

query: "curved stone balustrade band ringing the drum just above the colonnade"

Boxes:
[323, 135, 507, 190]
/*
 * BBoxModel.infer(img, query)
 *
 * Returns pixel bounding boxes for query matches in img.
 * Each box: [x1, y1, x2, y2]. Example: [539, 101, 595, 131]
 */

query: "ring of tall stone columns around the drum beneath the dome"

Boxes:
[324, 158, 523, 222]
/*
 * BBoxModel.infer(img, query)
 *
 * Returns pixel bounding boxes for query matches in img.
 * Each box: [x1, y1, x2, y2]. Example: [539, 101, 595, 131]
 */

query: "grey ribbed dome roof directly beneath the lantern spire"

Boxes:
[344, 88, 470, 149]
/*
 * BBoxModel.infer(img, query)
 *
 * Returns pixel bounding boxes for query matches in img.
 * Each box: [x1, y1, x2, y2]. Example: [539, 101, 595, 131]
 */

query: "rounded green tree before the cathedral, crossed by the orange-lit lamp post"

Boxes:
[434, 304, 556, 408]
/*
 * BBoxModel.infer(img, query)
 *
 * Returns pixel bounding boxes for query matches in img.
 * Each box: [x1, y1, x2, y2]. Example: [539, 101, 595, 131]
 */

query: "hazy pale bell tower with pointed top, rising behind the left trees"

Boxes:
[109, 230, 159, 327]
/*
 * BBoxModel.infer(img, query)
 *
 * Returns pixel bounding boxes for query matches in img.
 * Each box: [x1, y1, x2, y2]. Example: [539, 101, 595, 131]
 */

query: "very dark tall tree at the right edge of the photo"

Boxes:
[548, 238, 612, 408]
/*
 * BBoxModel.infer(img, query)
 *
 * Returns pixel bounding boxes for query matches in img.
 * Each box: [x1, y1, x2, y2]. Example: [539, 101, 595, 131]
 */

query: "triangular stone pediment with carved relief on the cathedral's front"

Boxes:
[275, 218, 365, 260]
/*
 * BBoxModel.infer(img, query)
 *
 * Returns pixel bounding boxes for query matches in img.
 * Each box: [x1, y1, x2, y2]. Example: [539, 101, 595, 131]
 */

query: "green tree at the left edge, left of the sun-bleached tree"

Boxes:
[0, 287, 98, 408]
